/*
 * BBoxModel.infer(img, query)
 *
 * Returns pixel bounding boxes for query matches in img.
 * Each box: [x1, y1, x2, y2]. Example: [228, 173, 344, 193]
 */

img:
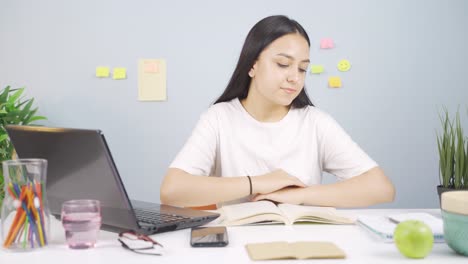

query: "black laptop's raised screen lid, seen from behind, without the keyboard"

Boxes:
[6, 126, 137, 228]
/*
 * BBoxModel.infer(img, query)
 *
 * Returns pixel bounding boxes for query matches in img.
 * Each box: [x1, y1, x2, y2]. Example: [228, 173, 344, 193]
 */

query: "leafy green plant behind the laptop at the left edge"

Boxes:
[0, 86, 46, 206]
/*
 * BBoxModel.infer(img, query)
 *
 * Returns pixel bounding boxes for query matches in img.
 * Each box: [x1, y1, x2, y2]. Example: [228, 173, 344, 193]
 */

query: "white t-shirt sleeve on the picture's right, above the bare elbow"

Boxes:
[318, 114, 378, 179]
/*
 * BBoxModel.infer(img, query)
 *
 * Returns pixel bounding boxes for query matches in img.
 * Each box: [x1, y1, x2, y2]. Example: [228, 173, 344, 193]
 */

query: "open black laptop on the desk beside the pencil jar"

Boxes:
[6, 125, 219, 234]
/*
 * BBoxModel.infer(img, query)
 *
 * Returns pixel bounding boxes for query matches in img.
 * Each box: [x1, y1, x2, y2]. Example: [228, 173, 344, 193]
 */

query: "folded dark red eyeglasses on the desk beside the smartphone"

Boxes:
[118, 231, 163, 256]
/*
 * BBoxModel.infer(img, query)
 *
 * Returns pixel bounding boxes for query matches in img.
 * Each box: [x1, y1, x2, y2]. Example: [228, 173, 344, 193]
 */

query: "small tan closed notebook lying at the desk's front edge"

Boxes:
[245, 241, 346, 260]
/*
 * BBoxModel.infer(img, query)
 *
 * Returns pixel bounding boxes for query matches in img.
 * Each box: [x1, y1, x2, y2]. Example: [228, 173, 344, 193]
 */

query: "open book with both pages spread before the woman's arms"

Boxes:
[219, 201, 354, 226]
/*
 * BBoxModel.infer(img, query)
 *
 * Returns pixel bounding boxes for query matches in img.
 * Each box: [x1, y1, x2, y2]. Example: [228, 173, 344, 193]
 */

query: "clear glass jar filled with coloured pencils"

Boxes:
[1, 159, 50, 251]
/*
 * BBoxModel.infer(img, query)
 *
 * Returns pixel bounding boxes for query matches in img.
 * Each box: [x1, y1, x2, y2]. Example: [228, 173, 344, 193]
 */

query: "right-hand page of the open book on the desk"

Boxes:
[278, 204, 354, 224]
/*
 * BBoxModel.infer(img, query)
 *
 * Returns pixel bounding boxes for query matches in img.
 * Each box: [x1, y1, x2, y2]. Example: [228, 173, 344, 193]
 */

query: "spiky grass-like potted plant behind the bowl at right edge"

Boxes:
[437, 109, 468, 201]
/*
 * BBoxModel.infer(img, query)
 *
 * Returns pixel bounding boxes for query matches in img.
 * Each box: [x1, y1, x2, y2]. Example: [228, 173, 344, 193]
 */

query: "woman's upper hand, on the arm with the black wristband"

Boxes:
[251, 169, 306, 194]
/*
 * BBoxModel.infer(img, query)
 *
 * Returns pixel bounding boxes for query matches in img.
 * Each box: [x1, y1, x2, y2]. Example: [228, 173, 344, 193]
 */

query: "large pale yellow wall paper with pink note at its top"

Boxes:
[138, 59, 167, 101]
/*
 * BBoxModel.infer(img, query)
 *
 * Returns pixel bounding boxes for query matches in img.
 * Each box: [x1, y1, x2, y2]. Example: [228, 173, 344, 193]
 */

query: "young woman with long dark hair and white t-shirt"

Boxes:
[161, 16, 395, 207]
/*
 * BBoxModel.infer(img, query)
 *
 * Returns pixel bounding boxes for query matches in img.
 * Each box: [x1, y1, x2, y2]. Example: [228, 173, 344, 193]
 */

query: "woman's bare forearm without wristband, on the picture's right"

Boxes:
[300, 167, 395, 207]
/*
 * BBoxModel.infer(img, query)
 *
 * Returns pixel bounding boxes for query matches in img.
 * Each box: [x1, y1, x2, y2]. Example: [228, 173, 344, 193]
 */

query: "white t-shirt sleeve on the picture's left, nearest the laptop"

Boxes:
[169, 110, 218, 176]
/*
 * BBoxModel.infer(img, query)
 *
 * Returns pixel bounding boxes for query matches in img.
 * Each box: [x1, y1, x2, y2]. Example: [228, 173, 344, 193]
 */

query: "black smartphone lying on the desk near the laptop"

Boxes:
[190, 226, 229, 247]
